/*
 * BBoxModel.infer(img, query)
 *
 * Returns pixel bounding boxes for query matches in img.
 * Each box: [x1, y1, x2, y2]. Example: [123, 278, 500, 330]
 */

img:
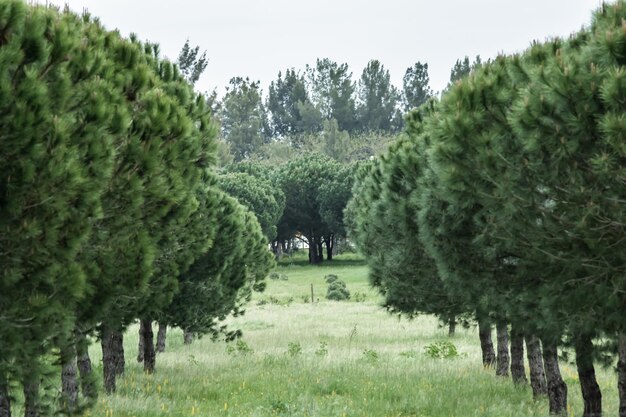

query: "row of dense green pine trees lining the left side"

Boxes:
[0, 0, 272, 417]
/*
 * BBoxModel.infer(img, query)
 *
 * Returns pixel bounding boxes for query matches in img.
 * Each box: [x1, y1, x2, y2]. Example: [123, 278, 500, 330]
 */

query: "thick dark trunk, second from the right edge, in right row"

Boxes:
[574, 335, 602, 417]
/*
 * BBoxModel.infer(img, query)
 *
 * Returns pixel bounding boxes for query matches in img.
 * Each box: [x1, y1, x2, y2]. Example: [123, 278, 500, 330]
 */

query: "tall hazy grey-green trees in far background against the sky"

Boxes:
[214, 55, 434, 161]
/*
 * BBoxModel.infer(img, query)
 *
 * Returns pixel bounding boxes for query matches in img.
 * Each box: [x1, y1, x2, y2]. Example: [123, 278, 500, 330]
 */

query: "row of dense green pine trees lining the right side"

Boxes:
[347, 1, 626, 416]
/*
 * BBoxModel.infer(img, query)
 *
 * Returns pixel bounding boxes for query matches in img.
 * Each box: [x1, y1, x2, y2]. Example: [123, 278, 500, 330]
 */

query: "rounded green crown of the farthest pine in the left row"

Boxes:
[167, 189, 273, 337]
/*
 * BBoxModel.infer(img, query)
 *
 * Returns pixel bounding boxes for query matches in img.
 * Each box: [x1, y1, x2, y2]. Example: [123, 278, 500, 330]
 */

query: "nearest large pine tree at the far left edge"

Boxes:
[0, 0, 129, 411]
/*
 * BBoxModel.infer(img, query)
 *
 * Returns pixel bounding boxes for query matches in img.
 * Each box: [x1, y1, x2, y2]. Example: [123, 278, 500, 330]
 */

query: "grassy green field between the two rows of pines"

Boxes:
[79, 252, 617, 417]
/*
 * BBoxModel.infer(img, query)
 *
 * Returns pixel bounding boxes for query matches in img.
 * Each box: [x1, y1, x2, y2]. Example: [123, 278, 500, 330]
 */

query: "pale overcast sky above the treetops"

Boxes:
[40, 0, 600, 94]
